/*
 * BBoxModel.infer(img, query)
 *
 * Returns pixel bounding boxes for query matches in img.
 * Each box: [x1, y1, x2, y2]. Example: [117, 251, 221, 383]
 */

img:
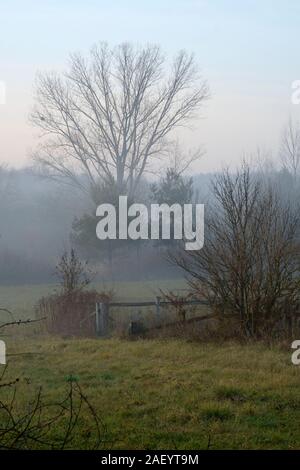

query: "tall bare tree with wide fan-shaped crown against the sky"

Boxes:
[31, 43, 209, 195]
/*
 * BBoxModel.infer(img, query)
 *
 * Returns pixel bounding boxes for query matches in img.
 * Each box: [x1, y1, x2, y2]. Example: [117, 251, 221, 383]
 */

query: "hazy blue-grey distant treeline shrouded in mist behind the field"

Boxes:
[0, 167, 299, 284]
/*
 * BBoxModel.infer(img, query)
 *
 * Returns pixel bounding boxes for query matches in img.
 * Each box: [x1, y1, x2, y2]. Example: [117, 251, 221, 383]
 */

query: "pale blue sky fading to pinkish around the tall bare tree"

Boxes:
[0, 0, 300, 171]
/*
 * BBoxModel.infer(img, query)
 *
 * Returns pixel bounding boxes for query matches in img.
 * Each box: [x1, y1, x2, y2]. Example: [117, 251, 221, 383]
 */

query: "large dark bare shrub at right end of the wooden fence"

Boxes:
[173, 164, 300, 338]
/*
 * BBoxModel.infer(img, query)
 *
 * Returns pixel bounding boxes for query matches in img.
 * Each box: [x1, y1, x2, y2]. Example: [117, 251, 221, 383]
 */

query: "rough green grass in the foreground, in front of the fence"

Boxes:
[0, 338, 300, 449]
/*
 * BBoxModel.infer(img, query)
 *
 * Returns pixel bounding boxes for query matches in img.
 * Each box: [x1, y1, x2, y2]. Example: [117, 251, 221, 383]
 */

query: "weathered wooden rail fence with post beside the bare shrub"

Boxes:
[96, 297, 213, 337]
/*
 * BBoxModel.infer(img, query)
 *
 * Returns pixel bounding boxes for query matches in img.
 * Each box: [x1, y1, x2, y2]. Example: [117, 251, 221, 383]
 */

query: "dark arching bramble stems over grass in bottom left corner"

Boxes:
[0, 375, 106, 450]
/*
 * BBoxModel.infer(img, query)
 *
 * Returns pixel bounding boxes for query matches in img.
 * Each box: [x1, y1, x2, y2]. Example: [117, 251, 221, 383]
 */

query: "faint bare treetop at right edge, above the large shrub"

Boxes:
[280, 119, 300, 178]
